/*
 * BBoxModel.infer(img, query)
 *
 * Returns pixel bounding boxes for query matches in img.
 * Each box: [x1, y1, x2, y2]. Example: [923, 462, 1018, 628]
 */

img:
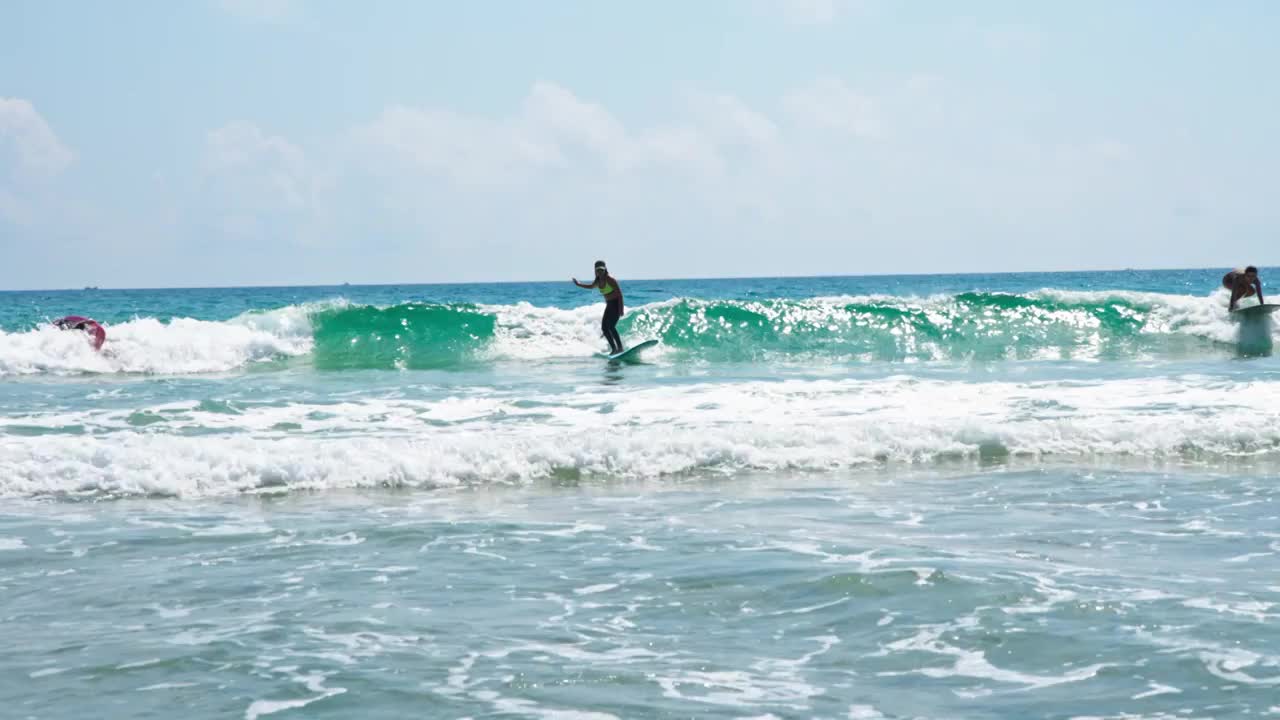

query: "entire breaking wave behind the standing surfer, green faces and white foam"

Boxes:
[0, 291, 1272, 375]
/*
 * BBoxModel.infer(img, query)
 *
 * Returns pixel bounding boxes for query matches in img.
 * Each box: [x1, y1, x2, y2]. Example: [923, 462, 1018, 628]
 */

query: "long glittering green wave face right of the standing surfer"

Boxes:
[621, 292, 1216, 361]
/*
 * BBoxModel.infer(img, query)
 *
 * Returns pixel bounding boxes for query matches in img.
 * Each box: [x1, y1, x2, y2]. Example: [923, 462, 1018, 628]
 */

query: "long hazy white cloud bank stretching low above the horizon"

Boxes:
[157, 76, 1198, 281]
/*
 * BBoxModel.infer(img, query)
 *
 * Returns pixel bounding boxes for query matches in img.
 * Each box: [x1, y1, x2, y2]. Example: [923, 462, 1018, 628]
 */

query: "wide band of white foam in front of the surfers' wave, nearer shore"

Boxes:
[0, 368, 1280, 491]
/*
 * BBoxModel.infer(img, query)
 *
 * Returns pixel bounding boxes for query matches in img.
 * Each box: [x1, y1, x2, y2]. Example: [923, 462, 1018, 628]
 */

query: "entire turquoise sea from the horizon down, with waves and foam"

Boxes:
[0, 270, 1280, 719]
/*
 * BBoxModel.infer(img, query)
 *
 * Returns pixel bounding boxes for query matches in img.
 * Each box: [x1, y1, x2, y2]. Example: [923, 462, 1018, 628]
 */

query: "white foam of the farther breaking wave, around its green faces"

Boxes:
[0, 290, 1272, 377]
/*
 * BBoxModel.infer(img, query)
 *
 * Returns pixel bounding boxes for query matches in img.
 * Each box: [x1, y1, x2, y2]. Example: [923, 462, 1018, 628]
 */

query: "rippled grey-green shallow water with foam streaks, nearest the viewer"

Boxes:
[0, 468, 1280, 717]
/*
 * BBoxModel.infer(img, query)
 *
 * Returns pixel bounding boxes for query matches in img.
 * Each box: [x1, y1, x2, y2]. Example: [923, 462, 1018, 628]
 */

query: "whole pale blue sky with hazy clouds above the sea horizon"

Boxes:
[0, 0, 1280, 290]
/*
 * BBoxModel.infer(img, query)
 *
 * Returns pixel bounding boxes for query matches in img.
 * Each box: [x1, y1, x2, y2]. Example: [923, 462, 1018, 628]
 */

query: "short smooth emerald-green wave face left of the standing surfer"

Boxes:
[311, 302, 494, 370]
